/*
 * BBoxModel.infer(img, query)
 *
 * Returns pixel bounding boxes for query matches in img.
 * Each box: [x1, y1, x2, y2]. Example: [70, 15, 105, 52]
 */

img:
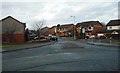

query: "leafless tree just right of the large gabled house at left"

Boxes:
[34, 20, 45, 40]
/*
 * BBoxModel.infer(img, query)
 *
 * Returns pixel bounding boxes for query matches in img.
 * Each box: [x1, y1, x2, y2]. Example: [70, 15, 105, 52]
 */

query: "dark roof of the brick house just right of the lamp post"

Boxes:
[76, 21, 103, 27]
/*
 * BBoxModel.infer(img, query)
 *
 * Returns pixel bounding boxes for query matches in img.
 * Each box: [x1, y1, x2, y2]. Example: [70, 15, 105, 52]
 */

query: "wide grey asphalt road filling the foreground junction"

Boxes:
[2, 38, 119, 71]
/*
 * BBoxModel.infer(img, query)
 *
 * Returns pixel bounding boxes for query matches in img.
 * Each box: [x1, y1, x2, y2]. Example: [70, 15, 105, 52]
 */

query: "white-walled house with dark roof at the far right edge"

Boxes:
[106, 19, 120, 39]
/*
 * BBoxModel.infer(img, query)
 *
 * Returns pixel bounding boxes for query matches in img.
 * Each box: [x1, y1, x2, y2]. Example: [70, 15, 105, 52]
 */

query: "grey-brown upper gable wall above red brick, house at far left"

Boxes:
[1, 16, 26, 34]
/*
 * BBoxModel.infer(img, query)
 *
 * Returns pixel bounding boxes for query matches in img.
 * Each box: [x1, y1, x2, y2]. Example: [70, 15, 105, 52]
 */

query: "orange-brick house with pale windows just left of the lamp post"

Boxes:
[56, 24, 74, 37]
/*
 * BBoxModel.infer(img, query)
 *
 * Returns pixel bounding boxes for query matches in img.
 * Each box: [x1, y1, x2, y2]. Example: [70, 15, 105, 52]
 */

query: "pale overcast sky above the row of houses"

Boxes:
[0, 0, 119, 29]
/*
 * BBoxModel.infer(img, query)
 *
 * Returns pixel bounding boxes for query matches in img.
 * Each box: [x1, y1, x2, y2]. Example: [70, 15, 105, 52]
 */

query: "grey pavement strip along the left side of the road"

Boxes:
[0, 41, 55, 53]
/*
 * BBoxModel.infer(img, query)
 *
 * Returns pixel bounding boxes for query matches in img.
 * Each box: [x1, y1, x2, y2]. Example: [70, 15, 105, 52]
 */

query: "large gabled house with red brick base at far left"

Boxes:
[0, 16, 26, 43]
